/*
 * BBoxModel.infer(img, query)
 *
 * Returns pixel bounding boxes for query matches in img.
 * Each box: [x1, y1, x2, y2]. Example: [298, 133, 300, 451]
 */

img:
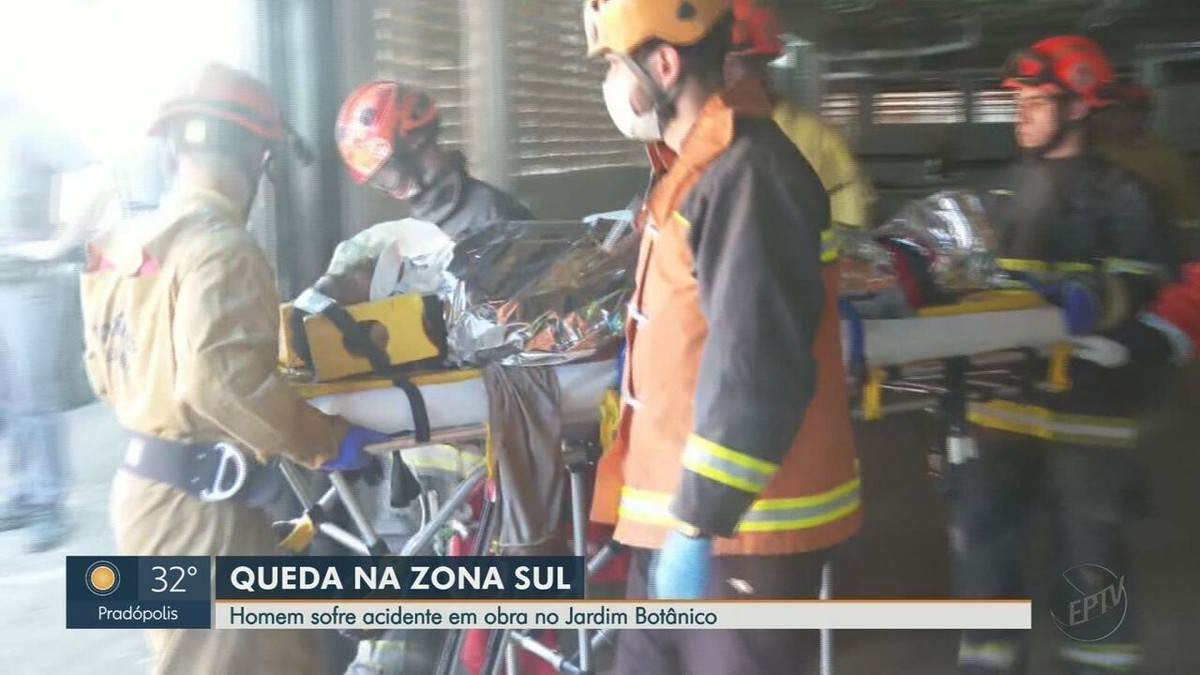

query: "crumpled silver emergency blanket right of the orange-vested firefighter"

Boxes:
[875, 190, 998, 295]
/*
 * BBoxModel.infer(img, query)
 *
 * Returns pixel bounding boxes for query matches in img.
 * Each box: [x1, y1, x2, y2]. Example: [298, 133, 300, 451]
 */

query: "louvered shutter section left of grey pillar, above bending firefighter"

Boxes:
[372, 0, 467, 149]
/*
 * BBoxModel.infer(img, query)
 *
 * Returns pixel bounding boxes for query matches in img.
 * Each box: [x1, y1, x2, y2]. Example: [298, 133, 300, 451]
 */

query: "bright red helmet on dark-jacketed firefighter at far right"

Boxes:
[1001, 35, 1116, 108]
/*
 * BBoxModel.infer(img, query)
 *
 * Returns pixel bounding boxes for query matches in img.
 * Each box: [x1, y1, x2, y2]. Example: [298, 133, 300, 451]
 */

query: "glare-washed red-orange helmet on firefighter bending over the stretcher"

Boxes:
[334, 79, 438, 183]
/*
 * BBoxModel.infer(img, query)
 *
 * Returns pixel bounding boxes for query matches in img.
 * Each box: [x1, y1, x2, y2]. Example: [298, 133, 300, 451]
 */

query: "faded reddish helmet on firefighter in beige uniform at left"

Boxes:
[150, 64, 287, 142]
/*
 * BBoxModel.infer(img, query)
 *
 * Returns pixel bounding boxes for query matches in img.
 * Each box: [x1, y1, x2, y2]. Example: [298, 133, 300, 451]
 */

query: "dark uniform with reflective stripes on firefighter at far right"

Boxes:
[969, 144, 1175, 675]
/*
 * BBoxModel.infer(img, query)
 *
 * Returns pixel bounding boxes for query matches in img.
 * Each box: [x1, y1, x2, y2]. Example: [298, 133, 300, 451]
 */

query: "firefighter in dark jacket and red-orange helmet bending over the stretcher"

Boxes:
[335, 80, 534, 241]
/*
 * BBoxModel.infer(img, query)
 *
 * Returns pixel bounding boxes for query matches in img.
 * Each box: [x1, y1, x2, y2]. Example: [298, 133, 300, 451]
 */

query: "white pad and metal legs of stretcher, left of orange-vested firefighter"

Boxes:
[283, 359, 622, 675]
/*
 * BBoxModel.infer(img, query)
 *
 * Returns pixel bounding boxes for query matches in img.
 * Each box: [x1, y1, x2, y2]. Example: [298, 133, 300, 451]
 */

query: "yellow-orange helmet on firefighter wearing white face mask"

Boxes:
[583, 0, 733, 56]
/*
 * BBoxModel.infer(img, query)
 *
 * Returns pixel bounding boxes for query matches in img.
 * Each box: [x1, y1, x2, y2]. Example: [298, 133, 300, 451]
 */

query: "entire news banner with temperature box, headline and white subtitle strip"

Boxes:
[66, 556, 1032, 631]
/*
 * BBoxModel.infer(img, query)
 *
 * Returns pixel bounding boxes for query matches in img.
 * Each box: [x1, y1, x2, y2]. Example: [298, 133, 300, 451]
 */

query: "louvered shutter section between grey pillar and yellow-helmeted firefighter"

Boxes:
[508, 0, 646, 175]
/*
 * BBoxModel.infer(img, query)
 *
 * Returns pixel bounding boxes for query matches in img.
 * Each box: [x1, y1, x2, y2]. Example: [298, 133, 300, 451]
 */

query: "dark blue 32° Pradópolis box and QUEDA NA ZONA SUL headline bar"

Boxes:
[66, 556, 587, 628]
